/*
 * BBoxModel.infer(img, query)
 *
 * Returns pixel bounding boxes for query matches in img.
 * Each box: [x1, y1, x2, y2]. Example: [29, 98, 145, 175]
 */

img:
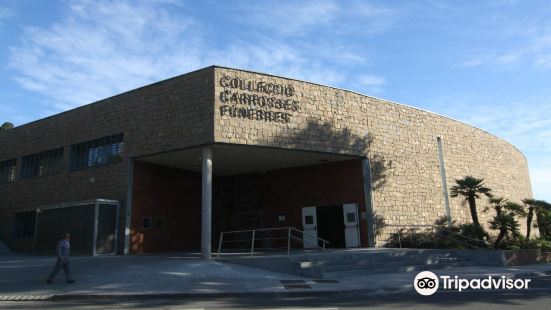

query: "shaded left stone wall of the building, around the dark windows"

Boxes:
[0, 68, 214, 250]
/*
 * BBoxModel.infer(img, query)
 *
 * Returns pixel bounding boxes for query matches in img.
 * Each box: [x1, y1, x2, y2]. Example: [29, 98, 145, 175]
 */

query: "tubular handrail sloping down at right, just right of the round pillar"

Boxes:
[218, 227, 330, 258]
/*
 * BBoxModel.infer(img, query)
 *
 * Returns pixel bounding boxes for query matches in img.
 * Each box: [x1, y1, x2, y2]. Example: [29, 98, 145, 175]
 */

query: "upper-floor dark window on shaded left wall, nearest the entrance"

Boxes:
[71, 133, 123, 170]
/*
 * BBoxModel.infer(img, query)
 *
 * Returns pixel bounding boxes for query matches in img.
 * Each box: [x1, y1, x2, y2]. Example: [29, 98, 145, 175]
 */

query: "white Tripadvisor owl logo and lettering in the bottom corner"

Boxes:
[413, 271, 531, 296]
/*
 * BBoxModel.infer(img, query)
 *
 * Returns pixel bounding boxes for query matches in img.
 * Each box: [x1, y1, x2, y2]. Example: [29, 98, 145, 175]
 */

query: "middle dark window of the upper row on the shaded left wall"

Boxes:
[21, 147, 63, 179]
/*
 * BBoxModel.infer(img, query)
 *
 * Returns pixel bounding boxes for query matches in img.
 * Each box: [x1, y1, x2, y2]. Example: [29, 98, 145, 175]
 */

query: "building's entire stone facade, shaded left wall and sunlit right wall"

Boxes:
[0, 67, 532, 252]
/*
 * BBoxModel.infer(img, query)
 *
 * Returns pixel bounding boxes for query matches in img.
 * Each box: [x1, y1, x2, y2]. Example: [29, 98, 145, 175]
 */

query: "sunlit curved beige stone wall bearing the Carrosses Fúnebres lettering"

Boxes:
[214, 68, 532, 232]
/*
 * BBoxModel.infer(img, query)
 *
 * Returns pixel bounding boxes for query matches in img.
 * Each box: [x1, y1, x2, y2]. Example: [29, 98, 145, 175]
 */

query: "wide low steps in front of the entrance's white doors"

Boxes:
[221, 249, 502, 279]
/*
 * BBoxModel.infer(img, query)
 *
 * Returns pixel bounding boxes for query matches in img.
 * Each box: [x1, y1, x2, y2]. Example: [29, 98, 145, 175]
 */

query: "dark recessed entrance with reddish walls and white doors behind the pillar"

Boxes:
[131, 144, 365, 253]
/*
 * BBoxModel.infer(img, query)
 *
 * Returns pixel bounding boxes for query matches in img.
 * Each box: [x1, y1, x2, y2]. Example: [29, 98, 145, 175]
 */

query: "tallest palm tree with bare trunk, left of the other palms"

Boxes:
[450, 175, 492, 227]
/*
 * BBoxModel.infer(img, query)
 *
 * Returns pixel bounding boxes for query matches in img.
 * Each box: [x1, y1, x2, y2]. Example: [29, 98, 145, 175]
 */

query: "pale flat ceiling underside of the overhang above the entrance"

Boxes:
[139, 144, 358, 176]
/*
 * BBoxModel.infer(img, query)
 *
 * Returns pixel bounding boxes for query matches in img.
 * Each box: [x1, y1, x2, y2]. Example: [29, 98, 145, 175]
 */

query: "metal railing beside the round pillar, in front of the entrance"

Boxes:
[218, 227, 329, 257]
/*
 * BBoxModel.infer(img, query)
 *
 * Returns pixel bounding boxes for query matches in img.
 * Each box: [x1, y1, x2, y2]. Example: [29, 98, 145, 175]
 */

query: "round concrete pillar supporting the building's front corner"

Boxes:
[201, 147, 212, 259]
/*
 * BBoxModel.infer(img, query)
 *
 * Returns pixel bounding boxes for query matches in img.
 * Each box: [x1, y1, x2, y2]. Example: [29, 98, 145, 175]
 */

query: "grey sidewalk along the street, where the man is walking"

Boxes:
[0, 254, 551, 301]
